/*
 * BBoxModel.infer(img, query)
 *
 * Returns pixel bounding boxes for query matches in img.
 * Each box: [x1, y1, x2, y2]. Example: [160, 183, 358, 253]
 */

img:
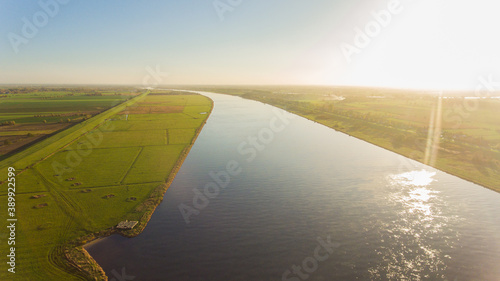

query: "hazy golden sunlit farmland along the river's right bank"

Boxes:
[194, 86, 500, 192]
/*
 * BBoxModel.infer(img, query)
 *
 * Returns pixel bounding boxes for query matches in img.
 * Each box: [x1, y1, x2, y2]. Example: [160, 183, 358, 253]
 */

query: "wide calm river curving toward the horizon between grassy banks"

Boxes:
[87, 93, 500, 281]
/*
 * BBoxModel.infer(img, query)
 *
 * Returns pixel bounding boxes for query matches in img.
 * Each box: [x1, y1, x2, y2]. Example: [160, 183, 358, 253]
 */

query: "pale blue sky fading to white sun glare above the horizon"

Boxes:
[0, 0, 500, 89]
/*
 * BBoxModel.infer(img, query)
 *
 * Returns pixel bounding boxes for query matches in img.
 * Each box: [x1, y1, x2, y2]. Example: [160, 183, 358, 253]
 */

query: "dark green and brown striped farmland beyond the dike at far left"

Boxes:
[0, 89, 136, 156]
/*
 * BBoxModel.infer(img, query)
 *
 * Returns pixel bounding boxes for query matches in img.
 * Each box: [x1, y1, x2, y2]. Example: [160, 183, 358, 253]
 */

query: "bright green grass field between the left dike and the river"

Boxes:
[0, 89, 212, 280]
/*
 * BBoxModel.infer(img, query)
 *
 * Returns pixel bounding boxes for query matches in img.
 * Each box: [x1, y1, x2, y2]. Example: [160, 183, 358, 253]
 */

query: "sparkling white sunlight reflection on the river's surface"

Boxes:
[369, 170, 458, 280]
